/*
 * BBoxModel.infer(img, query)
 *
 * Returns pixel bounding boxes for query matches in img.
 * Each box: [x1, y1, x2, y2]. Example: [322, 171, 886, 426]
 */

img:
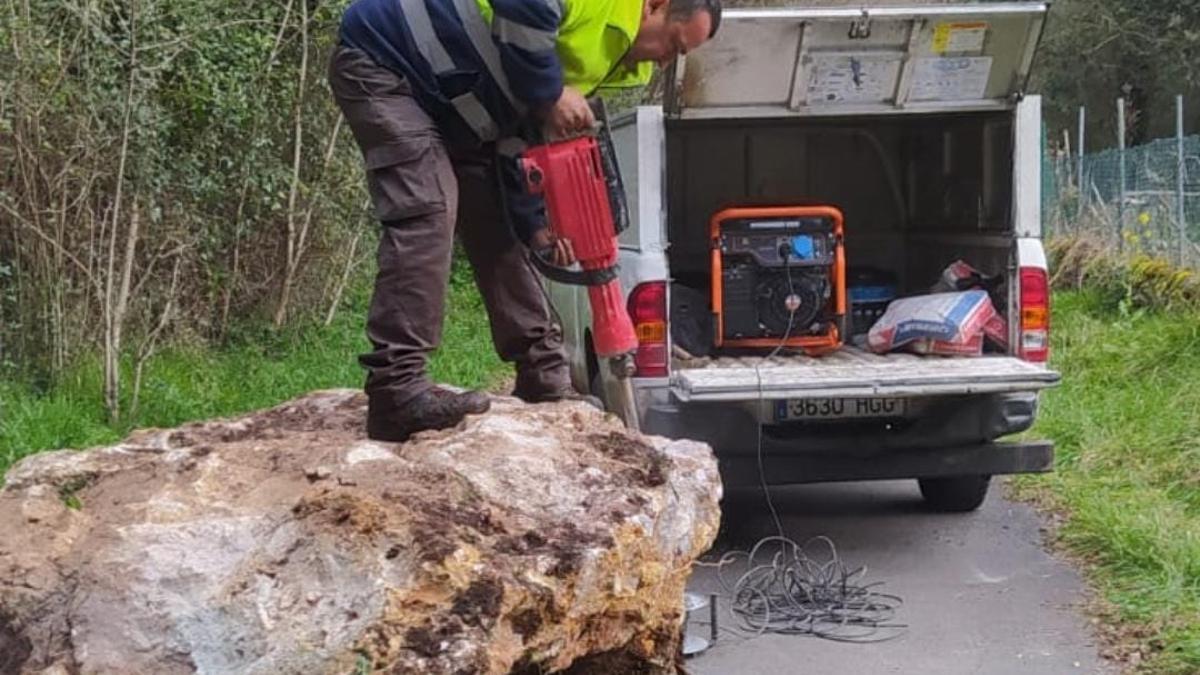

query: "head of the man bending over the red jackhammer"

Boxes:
[629, 0, 721, 65]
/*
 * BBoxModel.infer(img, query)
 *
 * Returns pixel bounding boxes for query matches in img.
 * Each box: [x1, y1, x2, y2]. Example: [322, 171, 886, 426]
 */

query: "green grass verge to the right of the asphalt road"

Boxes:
[1018, 293, 1200, 675]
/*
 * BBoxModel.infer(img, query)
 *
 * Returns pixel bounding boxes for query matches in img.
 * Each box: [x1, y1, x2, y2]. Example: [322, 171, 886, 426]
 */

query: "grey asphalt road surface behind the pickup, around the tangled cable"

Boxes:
[686, 482, 1115, 675]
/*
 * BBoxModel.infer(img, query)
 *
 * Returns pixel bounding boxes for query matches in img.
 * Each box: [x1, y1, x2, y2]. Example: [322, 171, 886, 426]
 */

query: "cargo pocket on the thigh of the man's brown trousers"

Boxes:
[366, 135, 446, 222]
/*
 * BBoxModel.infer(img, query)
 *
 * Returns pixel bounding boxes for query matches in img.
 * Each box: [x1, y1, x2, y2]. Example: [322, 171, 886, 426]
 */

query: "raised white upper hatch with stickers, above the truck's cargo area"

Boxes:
[665, 1, 1049, 118]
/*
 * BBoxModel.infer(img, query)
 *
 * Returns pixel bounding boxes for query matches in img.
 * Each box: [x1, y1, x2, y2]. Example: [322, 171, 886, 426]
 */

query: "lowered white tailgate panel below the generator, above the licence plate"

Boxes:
[671, 347, 1061, 402]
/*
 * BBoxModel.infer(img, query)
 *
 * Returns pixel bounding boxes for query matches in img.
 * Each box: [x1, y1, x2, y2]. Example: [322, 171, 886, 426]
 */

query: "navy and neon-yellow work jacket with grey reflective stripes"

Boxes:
[340, 0, 650, 143]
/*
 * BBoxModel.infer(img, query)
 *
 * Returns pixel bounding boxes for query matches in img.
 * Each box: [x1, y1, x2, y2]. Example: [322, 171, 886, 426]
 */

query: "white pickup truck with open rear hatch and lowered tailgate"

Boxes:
[550, 1, 1060, 512]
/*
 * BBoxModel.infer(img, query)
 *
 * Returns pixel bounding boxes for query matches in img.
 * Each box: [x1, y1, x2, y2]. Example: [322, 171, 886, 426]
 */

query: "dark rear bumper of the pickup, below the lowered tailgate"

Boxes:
[641, 393, 1054, 484]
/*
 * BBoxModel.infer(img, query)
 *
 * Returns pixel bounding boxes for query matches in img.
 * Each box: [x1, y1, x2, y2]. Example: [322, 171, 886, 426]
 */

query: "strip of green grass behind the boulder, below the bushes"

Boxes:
[0, 260, 504, 477]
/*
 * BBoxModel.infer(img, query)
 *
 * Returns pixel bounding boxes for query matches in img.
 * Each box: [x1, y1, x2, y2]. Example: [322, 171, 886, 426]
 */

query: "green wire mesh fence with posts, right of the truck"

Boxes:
[1043, 107, 1200, 268]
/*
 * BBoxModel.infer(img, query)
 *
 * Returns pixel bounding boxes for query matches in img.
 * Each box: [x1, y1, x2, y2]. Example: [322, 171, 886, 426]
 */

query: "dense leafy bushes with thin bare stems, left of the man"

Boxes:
[0, 0, 372, 391]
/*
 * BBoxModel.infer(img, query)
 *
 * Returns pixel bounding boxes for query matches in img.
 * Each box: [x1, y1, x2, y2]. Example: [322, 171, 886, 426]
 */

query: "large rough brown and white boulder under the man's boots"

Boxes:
[0, 392, 721, 675]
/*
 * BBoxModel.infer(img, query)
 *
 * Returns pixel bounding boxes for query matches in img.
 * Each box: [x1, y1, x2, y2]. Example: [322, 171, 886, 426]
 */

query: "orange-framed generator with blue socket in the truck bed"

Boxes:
[710, 207, 847, 356]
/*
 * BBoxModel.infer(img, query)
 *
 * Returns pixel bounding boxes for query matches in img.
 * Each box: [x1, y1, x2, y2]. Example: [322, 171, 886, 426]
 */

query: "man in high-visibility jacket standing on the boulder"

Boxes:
[329, 0, 721, 442]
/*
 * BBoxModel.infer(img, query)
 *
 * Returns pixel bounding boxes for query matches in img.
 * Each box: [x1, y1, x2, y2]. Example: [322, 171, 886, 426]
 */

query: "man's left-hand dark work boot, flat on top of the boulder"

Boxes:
[367, 387, 492, 443]
